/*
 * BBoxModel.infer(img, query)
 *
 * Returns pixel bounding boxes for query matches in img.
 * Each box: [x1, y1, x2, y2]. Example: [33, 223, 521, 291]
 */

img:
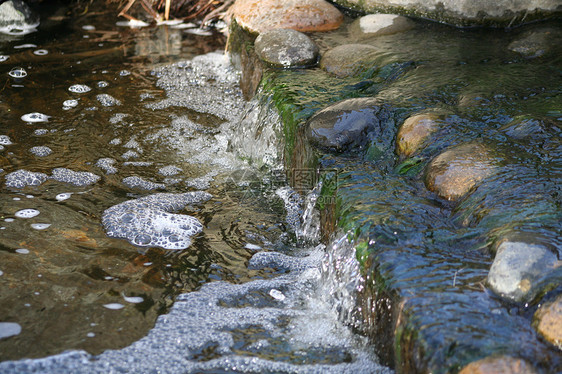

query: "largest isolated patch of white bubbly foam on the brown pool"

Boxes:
[102, 191, 211, 249]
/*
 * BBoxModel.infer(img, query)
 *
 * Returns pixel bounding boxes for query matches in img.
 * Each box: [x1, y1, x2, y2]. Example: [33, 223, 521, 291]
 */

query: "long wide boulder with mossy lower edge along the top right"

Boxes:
[334, 0, 562, 27]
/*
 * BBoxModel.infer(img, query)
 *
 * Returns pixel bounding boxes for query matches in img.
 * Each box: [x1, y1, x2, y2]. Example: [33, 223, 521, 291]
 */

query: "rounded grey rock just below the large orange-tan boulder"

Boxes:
[254, 29, 318, 68]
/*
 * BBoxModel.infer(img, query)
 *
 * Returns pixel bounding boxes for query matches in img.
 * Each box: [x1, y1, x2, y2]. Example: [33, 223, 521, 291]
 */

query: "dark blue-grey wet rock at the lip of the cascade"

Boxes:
[306, 98, 394, 152]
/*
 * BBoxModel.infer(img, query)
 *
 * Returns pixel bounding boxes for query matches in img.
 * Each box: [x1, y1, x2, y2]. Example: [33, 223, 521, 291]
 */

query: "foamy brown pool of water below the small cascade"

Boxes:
[0, 2, 388, 373]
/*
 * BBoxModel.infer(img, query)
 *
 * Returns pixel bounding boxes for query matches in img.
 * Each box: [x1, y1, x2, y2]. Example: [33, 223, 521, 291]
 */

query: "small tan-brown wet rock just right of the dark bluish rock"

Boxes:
[396, 112, 444, 157]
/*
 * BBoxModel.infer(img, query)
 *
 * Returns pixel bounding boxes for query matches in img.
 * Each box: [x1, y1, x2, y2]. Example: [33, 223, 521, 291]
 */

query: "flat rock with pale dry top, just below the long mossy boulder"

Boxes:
[350, 14, 415, 37]
